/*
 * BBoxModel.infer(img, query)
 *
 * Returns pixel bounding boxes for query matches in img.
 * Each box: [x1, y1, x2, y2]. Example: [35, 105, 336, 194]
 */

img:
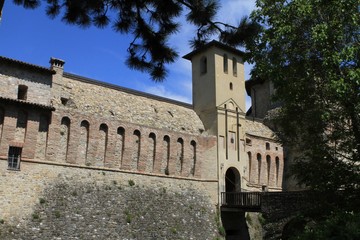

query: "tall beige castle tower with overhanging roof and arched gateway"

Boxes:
[184, 41, 246, 195]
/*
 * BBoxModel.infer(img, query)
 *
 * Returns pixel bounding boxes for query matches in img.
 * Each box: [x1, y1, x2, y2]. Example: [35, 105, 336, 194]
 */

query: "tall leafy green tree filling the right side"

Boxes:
[249, 0, 360, 239]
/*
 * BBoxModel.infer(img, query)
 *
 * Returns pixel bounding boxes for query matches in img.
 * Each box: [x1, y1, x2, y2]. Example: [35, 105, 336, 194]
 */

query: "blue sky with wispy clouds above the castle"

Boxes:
[0, 0, 255, 106]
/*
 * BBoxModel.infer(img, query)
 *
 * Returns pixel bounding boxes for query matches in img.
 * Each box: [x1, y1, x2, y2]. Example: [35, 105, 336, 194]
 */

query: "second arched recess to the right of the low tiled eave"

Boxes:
[76, 120, 90, 165]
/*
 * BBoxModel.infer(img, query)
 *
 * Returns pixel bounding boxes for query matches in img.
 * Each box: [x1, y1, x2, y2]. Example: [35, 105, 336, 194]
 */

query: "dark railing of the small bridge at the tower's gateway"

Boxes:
[221, 192, 262, 210]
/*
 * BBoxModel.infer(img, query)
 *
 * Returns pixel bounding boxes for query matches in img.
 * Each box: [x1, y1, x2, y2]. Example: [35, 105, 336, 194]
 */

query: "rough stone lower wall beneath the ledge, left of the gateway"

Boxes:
[0, 160, 218, 240]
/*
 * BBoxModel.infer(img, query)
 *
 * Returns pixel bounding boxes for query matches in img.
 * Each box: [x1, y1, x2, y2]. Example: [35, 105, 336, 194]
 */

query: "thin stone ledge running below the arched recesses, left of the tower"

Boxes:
[0, 156, 218, 182]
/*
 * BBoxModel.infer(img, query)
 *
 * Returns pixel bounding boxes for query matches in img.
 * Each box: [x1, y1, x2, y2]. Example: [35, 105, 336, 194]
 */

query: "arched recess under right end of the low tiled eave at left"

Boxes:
[35, 114, 49, 160]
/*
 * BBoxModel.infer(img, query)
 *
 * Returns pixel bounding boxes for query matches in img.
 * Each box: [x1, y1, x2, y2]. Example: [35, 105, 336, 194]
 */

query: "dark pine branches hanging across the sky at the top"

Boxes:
[13, 0, 257, 81]
